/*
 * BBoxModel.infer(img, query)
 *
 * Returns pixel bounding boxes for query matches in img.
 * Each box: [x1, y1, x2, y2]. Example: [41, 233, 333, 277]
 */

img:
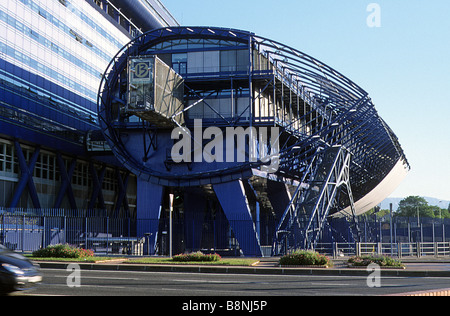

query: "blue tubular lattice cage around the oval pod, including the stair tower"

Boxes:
[98, 27, 409, 233]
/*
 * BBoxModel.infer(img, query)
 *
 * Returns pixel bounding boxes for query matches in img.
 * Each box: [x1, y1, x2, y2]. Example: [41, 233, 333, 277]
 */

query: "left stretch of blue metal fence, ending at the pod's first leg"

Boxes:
[0, 213, 144, 255]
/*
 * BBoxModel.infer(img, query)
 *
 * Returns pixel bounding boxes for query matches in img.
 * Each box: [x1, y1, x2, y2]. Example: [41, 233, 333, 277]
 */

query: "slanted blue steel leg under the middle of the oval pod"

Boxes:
[213, 180, 262, 257]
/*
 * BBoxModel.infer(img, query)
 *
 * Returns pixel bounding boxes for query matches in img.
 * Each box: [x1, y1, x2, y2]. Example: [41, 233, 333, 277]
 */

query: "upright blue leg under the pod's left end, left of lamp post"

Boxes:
[136, 178, 164, 255]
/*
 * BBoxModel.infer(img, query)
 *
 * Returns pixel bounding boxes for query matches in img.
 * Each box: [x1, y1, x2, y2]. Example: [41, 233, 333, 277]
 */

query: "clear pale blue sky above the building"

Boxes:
[161, 0, 450, 200]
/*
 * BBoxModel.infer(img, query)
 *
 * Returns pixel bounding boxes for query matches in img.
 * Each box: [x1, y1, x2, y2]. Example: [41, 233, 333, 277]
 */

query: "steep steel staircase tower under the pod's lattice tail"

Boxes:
[272, 146, 357, 255]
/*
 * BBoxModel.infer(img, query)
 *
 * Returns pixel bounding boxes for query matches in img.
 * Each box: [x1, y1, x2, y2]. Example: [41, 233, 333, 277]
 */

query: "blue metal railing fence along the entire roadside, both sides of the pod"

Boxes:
[0, 210, 450, 257]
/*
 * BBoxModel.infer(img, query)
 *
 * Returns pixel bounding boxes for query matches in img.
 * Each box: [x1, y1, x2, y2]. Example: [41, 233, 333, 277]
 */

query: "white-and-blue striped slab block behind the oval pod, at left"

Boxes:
[0, 0, 178, 216]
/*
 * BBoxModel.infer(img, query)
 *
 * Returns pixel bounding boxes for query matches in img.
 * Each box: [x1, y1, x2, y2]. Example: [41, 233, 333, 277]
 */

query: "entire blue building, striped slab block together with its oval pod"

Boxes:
[0, 0, 409, 256]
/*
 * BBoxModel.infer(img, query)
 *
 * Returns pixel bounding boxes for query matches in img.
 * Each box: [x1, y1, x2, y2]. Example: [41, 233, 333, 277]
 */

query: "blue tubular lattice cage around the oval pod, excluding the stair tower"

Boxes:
[98, 27, 408, 193]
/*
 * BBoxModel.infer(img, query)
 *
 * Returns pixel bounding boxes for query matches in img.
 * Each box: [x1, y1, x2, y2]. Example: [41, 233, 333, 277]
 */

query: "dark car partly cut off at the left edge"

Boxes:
[0, 245, 42, 294]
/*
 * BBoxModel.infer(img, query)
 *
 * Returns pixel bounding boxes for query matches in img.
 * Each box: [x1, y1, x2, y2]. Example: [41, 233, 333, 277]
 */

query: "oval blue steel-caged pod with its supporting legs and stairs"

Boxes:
[98, 27, 410, 256]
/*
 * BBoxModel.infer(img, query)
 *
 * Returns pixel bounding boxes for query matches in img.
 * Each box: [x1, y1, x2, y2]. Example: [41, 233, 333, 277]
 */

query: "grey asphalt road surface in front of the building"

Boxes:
[9, 269, 450, 298]
